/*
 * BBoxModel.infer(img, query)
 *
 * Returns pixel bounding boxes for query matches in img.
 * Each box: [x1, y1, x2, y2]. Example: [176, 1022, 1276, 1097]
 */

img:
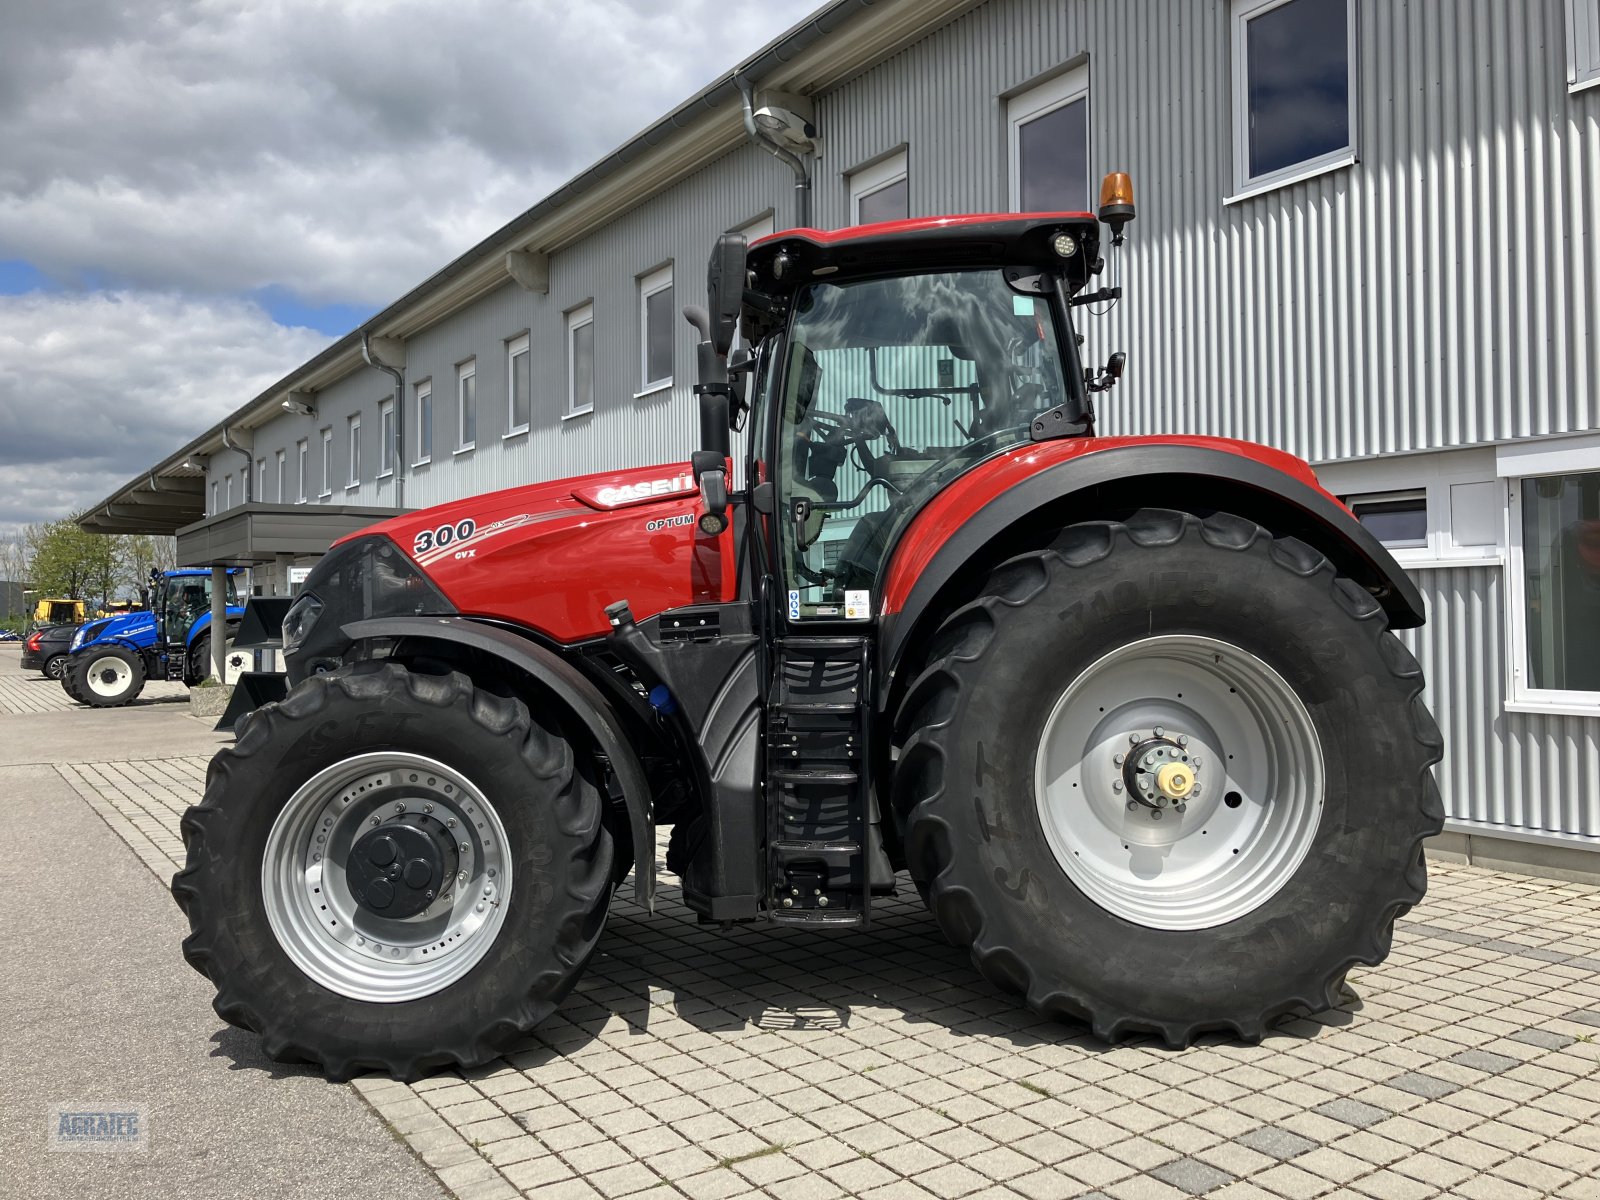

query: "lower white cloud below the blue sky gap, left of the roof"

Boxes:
[0, 291, 330, 538]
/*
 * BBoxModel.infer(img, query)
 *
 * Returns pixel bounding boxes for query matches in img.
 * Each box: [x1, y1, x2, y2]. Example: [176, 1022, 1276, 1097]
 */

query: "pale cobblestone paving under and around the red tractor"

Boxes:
[61, 758, 1600, 1200]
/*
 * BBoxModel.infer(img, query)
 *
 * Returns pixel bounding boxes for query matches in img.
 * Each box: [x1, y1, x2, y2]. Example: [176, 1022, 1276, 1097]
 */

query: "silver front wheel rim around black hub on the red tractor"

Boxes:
[261, 750, 512, 1003]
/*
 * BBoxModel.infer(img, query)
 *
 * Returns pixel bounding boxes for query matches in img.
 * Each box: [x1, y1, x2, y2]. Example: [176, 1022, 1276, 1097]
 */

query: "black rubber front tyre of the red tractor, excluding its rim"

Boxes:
[173, 662, 613, 1080]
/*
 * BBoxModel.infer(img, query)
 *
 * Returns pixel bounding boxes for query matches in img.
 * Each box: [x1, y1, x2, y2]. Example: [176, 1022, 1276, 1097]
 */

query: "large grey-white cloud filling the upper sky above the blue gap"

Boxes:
[0, 0, 811, 304]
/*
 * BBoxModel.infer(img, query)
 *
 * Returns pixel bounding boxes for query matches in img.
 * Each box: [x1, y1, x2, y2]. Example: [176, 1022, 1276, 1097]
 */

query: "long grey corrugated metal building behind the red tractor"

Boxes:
[88, 0, 1600, 872]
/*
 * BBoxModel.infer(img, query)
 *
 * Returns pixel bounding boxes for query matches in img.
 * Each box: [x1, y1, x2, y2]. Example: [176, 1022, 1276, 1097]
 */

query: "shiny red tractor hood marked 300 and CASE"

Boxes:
[324, 462, 736, 643]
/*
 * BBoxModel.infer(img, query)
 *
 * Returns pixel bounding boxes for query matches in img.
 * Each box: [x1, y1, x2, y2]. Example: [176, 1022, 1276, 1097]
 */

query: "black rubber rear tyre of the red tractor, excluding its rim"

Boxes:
[894, 510, 1443, 1046]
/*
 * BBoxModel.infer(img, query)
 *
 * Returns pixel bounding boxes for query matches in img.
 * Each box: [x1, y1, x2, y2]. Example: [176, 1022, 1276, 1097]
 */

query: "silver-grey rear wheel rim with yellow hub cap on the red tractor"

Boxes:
[1034, 634, 1325, 930]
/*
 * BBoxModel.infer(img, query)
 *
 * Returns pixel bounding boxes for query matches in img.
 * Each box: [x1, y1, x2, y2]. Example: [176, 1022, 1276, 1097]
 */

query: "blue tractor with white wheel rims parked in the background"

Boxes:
[61, 570, 245, 709]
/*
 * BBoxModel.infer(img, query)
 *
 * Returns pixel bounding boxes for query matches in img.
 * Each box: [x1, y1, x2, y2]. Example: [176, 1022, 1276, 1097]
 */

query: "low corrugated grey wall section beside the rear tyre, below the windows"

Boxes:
[1400, 565, 1600, 837]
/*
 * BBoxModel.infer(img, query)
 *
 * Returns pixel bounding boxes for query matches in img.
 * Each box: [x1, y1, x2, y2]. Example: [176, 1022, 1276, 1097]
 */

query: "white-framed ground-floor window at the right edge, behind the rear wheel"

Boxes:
[1512, 470, 1600, 712]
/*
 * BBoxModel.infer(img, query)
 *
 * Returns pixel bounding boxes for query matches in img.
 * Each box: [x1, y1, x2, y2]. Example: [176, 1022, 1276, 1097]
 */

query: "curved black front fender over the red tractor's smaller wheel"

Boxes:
[342, 616, 656, 912]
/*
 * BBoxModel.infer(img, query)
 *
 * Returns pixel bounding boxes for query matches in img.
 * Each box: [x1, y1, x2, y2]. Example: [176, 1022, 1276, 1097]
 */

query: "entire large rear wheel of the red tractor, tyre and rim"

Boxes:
[894, 510, 1443, 1046]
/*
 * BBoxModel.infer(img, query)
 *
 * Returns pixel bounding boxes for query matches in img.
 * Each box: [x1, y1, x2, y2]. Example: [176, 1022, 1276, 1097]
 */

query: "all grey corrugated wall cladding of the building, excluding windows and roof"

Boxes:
[211, 0, 1600, 837]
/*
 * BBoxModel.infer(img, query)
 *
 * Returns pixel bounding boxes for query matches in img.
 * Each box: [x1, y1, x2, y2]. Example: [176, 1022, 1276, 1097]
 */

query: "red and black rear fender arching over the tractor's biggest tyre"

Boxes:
[878, 438, 1426, 701]
